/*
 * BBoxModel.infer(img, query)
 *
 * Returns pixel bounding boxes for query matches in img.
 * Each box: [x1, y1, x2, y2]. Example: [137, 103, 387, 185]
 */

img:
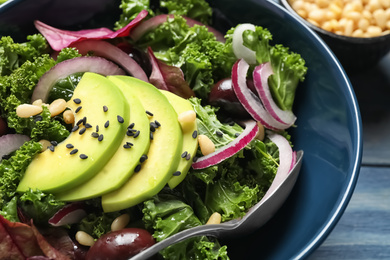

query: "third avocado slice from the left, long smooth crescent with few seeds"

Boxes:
[102, 76, 183, 212]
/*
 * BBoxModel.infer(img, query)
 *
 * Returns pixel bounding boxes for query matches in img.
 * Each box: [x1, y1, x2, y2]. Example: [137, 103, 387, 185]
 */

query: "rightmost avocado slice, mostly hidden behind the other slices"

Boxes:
[160, 90, 198, 189]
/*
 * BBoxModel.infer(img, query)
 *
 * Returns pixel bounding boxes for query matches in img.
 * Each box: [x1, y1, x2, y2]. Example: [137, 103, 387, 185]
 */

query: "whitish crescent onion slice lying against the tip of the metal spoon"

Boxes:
[262, 131, 296, 200]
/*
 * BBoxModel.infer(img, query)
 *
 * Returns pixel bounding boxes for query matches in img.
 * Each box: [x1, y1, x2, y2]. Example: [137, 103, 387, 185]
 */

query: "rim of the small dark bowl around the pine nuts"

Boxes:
[279, 0, 390, 44]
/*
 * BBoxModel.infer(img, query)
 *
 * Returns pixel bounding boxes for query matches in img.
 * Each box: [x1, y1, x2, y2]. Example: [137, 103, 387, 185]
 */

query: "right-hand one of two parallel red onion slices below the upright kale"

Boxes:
[253, 62, 297, 126]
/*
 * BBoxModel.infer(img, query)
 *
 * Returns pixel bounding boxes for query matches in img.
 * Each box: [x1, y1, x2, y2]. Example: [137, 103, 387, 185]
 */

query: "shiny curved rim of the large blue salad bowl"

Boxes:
[267, 0, 362, 259]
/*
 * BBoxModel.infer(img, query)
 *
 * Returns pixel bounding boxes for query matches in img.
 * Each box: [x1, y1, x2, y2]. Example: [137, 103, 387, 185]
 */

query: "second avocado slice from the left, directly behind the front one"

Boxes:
[55, 84, 150, 201]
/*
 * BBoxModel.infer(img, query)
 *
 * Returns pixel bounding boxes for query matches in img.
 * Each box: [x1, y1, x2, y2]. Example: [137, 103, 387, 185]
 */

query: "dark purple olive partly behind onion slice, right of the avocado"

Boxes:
[209, 78, 256, 118]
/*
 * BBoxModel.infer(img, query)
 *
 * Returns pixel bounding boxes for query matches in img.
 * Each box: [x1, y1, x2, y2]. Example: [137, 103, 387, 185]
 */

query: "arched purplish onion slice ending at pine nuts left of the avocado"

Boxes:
[31, 57, 126, 103]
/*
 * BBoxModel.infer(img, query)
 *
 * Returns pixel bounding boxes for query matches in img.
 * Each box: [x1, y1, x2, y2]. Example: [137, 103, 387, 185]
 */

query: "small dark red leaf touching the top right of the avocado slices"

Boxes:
[148, 47, 195, 98]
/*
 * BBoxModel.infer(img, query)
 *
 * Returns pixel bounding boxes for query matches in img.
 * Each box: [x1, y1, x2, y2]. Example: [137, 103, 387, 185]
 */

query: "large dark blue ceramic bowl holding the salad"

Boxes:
[0, 0, 362, 259]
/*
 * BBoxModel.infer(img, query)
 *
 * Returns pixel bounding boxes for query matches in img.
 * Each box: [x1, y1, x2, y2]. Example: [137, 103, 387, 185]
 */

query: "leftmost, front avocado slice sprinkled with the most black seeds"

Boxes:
[17, 73, 129, 193]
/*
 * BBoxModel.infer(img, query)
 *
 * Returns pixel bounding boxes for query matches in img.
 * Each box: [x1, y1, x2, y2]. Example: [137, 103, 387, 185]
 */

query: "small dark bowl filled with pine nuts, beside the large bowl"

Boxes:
[281, 0, 390, 73]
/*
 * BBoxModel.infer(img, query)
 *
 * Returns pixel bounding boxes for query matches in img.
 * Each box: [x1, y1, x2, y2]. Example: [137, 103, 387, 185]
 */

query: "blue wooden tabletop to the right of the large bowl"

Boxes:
[309, 54, 390, 260]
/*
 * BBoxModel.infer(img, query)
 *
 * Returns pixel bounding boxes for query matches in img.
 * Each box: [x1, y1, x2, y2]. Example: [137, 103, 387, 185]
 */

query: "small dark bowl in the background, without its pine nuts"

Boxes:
[280, 0, 390, 73]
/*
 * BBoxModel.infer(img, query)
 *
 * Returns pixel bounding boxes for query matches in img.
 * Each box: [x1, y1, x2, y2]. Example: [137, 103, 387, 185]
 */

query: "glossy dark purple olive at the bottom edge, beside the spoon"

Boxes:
[85, 228, 155, 260]
